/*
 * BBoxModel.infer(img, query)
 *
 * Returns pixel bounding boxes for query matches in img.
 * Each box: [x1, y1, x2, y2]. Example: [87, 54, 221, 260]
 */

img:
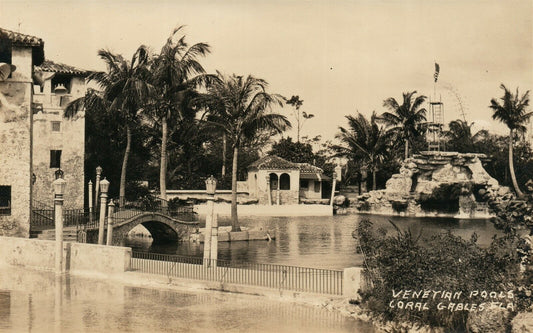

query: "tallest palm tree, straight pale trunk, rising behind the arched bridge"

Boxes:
[152, 26, 209, 200]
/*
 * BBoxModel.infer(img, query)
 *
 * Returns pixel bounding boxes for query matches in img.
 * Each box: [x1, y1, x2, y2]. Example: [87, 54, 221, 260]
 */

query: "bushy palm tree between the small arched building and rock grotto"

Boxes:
[334, 112, 393, 190]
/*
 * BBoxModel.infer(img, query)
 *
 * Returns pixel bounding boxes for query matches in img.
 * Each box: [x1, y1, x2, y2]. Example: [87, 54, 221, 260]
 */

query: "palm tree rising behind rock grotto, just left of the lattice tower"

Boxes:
[379, 91, 427, 159]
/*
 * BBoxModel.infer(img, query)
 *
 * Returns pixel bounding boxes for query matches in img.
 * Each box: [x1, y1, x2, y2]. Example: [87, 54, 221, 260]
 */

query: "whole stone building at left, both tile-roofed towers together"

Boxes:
[0, 28, 85, 237]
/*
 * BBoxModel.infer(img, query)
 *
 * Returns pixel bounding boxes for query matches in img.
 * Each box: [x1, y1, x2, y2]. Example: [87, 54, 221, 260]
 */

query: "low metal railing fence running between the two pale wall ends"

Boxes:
[131, 252, 343, 295]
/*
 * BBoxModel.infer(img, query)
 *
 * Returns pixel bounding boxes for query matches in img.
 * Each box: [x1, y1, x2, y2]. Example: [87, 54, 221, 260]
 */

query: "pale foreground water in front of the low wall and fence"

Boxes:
[0, 269, 372, 332]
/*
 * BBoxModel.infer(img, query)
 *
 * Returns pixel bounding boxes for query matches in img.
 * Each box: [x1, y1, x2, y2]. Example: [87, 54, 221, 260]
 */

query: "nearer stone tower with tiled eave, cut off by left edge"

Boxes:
[0, 28, 44, 237]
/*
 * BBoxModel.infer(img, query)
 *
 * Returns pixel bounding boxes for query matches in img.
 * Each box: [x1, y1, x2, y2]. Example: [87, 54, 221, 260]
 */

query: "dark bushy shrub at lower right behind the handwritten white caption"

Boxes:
[354, 219, 531, 331]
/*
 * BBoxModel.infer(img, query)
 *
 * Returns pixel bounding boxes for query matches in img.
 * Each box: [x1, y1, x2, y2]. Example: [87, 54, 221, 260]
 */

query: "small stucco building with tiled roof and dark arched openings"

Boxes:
[246, 155, 331, 205]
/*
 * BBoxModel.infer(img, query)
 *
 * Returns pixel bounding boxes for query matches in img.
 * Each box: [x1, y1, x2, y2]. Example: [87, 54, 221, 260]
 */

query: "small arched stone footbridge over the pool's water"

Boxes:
[112, 212, 198, 245]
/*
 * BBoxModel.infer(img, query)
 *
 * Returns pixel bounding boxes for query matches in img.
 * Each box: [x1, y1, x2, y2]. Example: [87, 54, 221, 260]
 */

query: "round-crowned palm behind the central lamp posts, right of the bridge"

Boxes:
[203, 73, 291, 231]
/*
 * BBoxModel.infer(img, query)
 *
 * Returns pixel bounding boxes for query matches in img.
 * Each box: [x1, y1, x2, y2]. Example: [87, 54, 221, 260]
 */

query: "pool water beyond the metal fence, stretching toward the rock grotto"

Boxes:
[126, 215, 498, 269]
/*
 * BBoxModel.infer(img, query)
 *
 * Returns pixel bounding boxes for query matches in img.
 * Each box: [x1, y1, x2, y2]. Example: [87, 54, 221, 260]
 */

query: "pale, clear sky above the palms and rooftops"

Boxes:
[0, 0, 533, 139]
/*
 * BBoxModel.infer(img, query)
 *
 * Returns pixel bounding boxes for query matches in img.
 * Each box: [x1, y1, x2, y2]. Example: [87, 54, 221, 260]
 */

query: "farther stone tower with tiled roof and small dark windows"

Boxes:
[33, 60, 87, 208]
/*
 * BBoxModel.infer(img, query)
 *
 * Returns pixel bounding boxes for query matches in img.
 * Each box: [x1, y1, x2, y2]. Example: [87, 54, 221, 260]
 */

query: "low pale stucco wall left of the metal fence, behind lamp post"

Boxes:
[0, 233, 131, 274]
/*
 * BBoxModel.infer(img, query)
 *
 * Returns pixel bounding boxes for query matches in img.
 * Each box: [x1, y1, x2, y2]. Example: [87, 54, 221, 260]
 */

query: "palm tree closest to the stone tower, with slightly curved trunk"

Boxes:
[65, 46, 152, 205]
